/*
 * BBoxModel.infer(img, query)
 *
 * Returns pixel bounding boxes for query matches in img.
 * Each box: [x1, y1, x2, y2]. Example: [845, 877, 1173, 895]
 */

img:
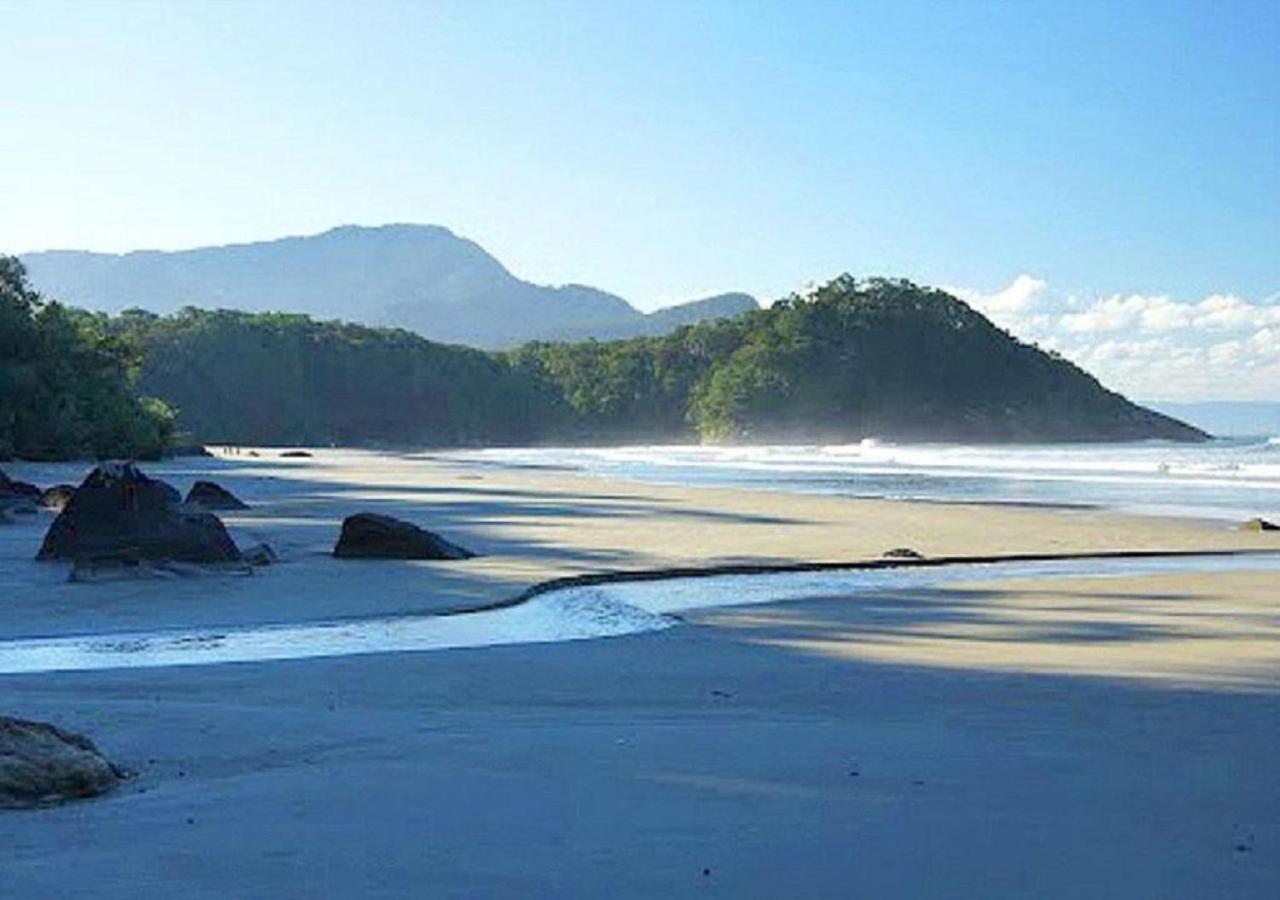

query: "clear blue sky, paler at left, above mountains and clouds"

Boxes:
[0, 0, 1280, 397]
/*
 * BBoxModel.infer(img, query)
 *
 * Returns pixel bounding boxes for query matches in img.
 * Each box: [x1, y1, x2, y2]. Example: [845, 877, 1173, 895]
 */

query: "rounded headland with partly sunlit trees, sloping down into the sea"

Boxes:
[511, 275, 1202, 442]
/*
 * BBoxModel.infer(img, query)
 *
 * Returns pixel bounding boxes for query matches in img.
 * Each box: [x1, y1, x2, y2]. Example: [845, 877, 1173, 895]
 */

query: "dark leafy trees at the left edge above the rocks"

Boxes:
[0, 256, 173, 460]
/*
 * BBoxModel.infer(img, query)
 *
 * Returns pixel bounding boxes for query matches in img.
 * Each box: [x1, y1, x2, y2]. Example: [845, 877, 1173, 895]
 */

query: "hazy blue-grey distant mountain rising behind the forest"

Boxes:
[22, 225, 758, 348]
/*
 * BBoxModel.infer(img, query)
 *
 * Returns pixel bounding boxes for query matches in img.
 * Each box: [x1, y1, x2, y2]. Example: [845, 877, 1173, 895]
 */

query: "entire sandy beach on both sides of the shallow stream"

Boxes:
[0, 452, 1280, 897]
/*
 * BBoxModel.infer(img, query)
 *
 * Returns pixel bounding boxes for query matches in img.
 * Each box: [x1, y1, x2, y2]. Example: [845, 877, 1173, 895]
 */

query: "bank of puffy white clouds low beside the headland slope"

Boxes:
[947, 275, 1280, 401]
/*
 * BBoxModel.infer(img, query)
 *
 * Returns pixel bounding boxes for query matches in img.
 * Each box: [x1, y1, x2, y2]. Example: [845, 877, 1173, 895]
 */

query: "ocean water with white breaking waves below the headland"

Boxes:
[445, 437, 1280, 521]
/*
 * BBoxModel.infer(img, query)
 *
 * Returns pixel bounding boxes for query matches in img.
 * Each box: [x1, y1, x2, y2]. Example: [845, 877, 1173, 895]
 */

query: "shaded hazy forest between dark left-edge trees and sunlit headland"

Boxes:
[111, 309, 547, 446]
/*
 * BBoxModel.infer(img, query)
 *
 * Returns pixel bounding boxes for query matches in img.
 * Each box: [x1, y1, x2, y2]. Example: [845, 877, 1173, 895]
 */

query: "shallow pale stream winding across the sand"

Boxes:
[0, 554, 1280, 675]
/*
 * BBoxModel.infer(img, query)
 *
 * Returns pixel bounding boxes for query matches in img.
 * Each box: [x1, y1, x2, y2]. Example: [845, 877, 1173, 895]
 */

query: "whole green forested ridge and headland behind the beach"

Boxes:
[110, 277, 1204, 446]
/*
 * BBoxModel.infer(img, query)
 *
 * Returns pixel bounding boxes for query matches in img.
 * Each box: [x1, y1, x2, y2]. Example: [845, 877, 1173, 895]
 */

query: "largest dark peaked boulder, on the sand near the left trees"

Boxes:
[36, 462, 241, 565]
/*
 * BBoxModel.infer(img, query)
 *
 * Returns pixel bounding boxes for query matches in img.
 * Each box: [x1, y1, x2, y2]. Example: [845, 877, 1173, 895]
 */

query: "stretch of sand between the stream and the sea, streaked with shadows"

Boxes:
[0, 451, 1280, 640]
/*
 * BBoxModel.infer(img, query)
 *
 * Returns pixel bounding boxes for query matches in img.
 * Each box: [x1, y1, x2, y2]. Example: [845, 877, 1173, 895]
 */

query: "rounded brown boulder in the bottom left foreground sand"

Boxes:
[0, 716, 124, 809]
